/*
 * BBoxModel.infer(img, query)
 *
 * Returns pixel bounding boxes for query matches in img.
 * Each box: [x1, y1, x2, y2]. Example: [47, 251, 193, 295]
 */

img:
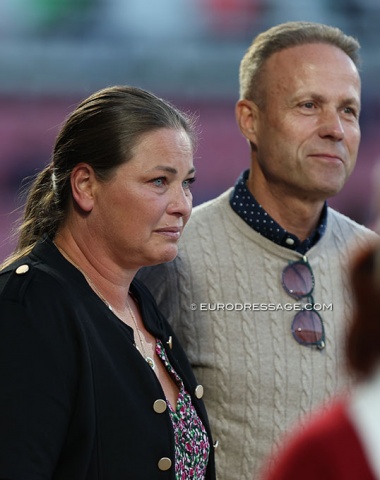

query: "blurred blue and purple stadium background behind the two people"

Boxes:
[0, 0, 380, 261]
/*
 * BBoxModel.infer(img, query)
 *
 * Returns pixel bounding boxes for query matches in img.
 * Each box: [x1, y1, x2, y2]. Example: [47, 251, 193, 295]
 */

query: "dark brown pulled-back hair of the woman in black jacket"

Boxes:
[2, 86, 196, 267]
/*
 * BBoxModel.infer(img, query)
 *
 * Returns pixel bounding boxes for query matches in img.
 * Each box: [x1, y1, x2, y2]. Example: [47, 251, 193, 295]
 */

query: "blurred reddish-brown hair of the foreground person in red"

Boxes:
[346, 245, 380, 378]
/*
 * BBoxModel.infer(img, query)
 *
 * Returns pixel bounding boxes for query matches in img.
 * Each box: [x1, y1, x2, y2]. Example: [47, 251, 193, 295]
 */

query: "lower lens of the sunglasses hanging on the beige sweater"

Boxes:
[292, 310, 324, 348]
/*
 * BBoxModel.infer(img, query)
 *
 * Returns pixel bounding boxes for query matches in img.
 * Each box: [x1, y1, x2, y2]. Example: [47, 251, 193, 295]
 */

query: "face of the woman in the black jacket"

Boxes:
[88, 128, 195, 269]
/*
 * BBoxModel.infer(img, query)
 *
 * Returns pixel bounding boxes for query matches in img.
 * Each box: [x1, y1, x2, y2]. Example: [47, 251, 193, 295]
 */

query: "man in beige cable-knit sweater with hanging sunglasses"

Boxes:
[140, 22, 376, 480]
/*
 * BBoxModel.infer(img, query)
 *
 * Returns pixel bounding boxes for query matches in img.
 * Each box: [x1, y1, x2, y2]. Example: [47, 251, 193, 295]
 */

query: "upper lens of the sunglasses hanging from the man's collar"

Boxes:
[282, 262, 314, 299]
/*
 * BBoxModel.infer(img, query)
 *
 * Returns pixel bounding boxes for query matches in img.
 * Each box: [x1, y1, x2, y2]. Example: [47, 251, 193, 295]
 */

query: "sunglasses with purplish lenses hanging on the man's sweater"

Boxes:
[282, 256, 326, 350]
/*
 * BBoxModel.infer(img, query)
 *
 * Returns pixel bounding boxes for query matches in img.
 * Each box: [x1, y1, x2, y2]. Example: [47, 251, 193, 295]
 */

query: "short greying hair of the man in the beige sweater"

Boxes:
[239, 22, 360, 105]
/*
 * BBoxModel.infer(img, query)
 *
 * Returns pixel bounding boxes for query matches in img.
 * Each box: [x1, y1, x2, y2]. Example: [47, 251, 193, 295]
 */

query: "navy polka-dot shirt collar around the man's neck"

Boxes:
[230, 170, 327, 255]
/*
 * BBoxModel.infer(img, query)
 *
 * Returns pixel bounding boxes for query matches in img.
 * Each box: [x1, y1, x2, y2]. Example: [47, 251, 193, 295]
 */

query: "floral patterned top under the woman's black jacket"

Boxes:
[156, 340, 210, 480]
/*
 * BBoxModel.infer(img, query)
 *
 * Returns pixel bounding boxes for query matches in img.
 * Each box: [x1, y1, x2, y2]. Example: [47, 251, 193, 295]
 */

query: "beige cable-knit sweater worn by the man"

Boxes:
[139, 191, 378, 480]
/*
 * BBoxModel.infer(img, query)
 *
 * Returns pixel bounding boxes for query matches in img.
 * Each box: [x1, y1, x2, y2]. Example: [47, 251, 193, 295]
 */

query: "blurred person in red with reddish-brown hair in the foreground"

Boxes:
[262, 245, 380, 480]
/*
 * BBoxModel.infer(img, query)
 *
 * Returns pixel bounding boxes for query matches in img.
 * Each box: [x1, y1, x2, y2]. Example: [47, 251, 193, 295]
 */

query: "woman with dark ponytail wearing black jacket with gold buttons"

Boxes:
[0, 87, 214, 480]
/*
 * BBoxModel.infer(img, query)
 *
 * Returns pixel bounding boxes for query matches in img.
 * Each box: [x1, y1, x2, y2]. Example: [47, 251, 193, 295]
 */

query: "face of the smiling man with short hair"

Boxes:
[251, 43, 360, 201]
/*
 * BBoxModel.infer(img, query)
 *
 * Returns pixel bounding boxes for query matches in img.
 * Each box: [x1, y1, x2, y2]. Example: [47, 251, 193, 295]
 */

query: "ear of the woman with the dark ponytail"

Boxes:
[70, 163, 96, 212]
